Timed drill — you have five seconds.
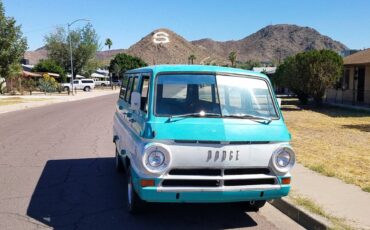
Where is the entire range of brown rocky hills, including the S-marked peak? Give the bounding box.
[25,24,347,64]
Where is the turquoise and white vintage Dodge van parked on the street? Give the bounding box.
[113,65,295,213]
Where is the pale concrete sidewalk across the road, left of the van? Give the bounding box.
[0,89,119,114]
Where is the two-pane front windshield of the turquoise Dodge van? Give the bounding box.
[155,74,278,118]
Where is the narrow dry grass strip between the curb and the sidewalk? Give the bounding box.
[289,192,353,230]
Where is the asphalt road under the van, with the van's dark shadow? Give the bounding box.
[0,95,299,229]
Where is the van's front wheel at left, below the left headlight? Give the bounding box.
[127,166,145,214]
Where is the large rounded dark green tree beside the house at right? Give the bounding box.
[276,50,343,104]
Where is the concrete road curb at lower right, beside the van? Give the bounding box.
[270,198,333,230]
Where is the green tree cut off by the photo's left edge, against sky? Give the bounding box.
[0,0,27,90]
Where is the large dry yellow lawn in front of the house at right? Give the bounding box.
[282,99,370,192]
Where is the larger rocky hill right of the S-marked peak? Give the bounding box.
[192,24,347,61]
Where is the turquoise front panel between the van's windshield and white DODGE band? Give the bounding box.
[150,118,291,142]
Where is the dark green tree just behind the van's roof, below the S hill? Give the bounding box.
[109,53,147,76]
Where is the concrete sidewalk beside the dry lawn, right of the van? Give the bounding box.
[292,164,370,229]
